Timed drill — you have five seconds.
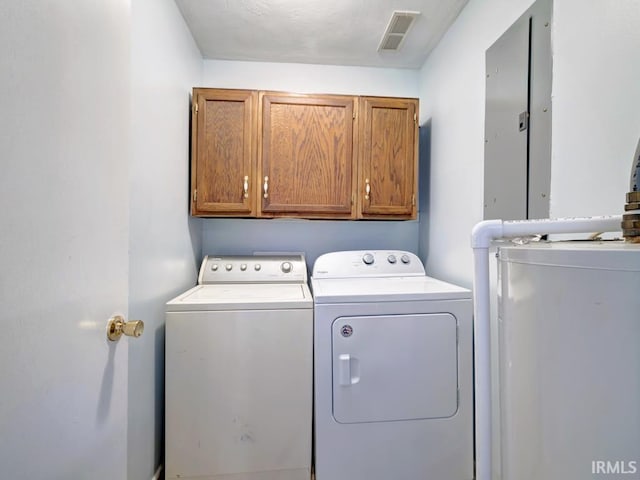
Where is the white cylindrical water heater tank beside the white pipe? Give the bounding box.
[494,241,640,480]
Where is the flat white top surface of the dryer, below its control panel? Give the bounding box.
[311,276,471,303]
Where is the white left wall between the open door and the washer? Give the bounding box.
[128,0,202,479]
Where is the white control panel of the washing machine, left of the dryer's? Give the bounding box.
[198,255,307,285]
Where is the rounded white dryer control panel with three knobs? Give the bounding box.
[312,250,425,278]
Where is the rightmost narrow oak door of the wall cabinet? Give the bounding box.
[358,97,418,219]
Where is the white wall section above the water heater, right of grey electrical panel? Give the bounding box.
[550,0,640,217]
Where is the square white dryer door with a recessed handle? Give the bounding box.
[332,313,458,423]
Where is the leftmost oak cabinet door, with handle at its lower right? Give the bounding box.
[191,88,257,216]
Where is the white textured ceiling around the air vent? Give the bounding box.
[176,0,468,68]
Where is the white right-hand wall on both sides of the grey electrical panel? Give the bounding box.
[420,0,640,286]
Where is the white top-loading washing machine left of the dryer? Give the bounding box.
[165,255,313,480]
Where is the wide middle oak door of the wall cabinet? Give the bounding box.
[258,92,356,218]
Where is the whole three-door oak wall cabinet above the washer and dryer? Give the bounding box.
[191,88,418,219]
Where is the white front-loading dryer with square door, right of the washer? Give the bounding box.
[311,251,473,480]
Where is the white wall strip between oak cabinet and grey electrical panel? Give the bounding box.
[420,0,533,287]
